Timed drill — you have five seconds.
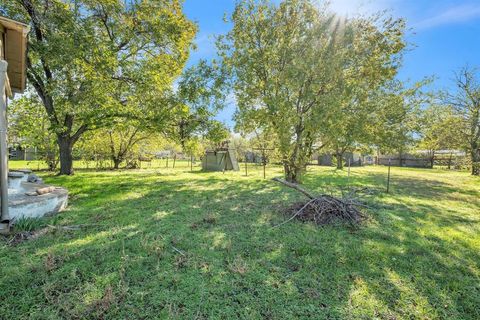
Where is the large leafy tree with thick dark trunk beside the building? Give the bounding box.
[0,0,196,174]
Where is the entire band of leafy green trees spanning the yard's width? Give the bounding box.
[0,0,480,182]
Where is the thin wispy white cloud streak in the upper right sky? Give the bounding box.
[414,4,480,29]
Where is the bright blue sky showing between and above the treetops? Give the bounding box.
[185,0,480,126]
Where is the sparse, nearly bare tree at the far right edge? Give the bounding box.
[445,67,480,176]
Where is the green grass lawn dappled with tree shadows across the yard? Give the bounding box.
[0,167,480,319]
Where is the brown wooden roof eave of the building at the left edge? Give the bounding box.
[0,16,30,92]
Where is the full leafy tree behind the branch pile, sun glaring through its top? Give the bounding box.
[219,0,405,182]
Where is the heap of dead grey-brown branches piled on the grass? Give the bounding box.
[273,178,366,227]
